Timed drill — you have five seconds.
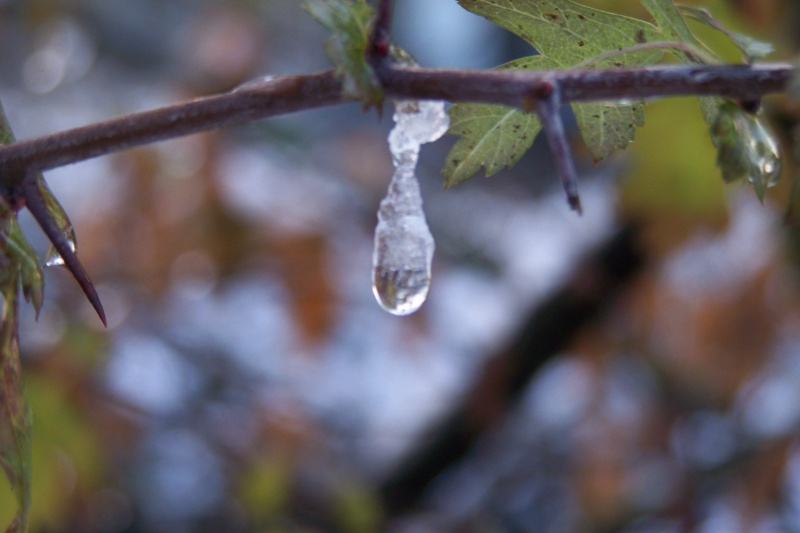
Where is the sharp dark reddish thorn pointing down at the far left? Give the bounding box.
[22,180,108,327]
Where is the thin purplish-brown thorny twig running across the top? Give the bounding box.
[0,64,794,175]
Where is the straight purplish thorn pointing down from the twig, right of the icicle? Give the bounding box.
[532,84,583,215]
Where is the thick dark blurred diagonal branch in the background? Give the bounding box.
[379,222,645,520]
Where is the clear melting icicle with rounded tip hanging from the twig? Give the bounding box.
[372,101,450,315]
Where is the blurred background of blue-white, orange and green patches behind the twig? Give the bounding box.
[0,0,800,533]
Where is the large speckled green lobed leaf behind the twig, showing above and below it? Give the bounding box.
[442,0,663,186]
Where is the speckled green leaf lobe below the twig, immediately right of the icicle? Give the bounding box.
[442,104,542,187]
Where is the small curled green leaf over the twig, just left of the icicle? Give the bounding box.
[303,0,383,107]
